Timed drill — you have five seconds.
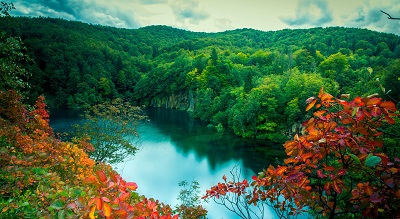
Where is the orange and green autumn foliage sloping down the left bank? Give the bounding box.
[0,90,178,218]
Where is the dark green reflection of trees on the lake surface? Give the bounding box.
[147,108,284,173]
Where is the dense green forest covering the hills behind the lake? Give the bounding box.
[0,17,400,141]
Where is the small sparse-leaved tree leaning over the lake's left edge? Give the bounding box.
[75,99,145,164]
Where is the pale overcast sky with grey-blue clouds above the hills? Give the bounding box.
[5,0,400,35]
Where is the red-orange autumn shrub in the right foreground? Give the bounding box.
[205,89,400,218]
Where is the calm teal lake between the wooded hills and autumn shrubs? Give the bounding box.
[50,108,283,219]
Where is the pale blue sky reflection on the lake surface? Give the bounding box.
[115,120,260,218]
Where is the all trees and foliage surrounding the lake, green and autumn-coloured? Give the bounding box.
[0,6,400,219]
